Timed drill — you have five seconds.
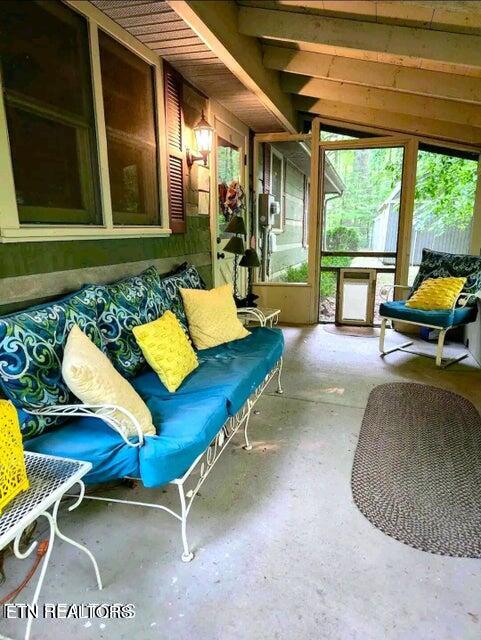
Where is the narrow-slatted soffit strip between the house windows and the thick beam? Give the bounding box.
[92,0,284,132]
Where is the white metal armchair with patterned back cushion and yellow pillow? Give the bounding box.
[379,249,481,368]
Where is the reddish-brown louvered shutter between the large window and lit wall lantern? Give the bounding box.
[164,62,186,233]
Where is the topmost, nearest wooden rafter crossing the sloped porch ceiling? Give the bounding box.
[237,3,481,73]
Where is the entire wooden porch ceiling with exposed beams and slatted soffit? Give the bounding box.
[93,0,481,148]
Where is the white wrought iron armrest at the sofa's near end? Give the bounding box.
[23,404,144,447]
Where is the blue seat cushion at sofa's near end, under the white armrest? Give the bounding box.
[24,418,140,484]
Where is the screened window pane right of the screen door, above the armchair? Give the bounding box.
[408,150,478,284]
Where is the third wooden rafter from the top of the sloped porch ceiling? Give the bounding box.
[282,74,481,127]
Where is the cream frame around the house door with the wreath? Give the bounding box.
[208,100,251,287]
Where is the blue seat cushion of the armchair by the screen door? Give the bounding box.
[379,300,477,328]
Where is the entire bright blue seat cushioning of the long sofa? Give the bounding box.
[25,328,284,487]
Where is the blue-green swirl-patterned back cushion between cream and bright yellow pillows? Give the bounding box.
[98,267,169,378]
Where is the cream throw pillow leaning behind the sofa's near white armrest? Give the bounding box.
[62,325,156,438]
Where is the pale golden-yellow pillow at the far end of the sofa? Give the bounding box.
[180,284,250,349]
